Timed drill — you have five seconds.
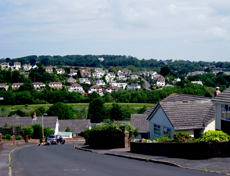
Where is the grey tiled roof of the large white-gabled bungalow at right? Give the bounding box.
[148,94,215,129]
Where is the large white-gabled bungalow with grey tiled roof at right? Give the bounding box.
[145,94,215,140]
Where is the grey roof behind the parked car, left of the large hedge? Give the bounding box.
[58,119,91,133]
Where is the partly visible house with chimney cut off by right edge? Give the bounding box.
[212,87,230,135]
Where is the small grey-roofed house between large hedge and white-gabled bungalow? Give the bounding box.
[130,114,149,139]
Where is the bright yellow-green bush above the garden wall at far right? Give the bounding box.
[198,130,230,142]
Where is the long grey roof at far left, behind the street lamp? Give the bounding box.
[0,115,57,130]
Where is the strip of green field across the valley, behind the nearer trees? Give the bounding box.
[0,103,154,117]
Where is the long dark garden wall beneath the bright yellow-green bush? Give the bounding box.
[130,142,230,159]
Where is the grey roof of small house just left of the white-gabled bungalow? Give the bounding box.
[130,114,148,133]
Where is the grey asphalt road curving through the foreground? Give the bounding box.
[12,144,220,176]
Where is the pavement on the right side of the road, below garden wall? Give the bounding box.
[74,143,230,175]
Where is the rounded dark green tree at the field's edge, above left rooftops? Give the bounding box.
[47,102,75,120]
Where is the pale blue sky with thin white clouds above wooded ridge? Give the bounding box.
[0,0,230,62]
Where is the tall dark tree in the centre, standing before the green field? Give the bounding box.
[88,97,106,123]
